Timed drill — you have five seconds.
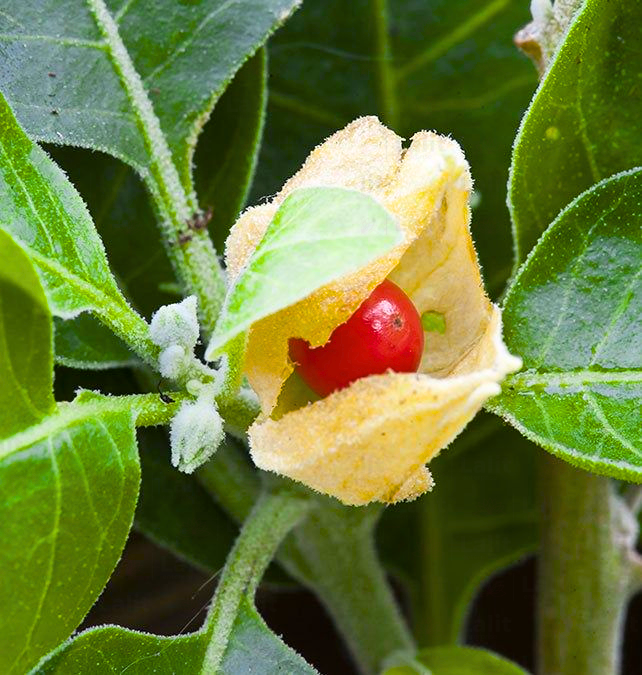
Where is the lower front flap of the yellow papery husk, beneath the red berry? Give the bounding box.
[249,307,521,505]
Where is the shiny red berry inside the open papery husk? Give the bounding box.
[290,280,424,396]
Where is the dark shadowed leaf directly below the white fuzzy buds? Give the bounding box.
[135,429,238,573]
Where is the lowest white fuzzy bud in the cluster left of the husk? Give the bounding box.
[169,398,225,473]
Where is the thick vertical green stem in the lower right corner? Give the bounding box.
[538,453,637,675]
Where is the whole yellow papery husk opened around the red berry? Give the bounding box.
[226,117,520,504]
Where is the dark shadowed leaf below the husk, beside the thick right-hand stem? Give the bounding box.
[377,414,538,645]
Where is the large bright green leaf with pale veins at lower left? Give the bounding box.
[0,396,140,673]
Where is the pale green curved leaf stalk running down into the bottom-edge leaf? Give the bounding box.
[201,491,310,675]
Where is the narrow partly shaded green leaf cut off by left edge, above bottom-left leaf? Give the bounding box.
[0,230,55,438]
